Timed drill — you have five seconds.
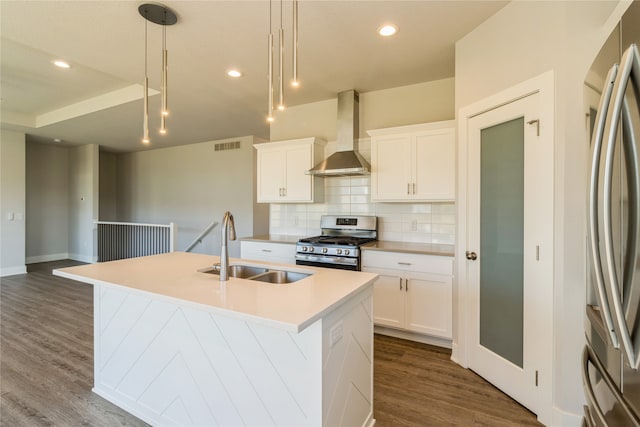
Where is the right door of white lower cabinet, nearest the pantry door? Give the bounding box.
[405,274,452,339]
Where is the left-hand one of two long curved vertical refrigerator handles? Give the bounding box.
[589,64,620,348]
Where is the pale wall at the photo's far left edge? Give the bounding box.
[0,130,27,277]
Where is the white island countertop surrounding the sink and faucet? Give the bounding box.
[53,252,377,332]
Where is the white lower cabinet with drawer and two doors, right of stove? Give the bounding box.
[362,250,453,339]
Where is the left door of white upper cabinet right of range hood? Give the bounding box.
[371,135,412,200]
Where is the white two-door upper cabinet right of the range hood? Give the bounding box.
[367,120,456,202]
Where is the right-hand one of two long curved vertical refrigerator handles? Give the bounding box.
[603,45,640,369]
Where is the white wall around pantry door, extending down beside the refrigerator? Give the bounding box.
[455,1,628,426]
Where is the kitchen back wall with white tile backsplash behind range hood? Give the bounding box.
[270,78,455,237]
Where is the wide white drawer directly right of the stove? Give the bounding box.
[362,250,453,276]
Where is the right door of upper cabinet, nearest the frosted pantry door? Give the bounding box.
[412,129,456,200]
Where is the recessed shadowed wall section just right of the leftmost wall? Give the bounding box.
[26,142,69,264]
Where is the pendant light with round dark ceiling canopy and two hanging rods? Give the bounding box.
[138,3,178,144]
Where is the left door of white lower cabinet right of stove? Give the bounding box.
[373,271,404,328]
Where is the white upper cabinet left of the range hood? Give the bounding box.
[254,138,326,203]
